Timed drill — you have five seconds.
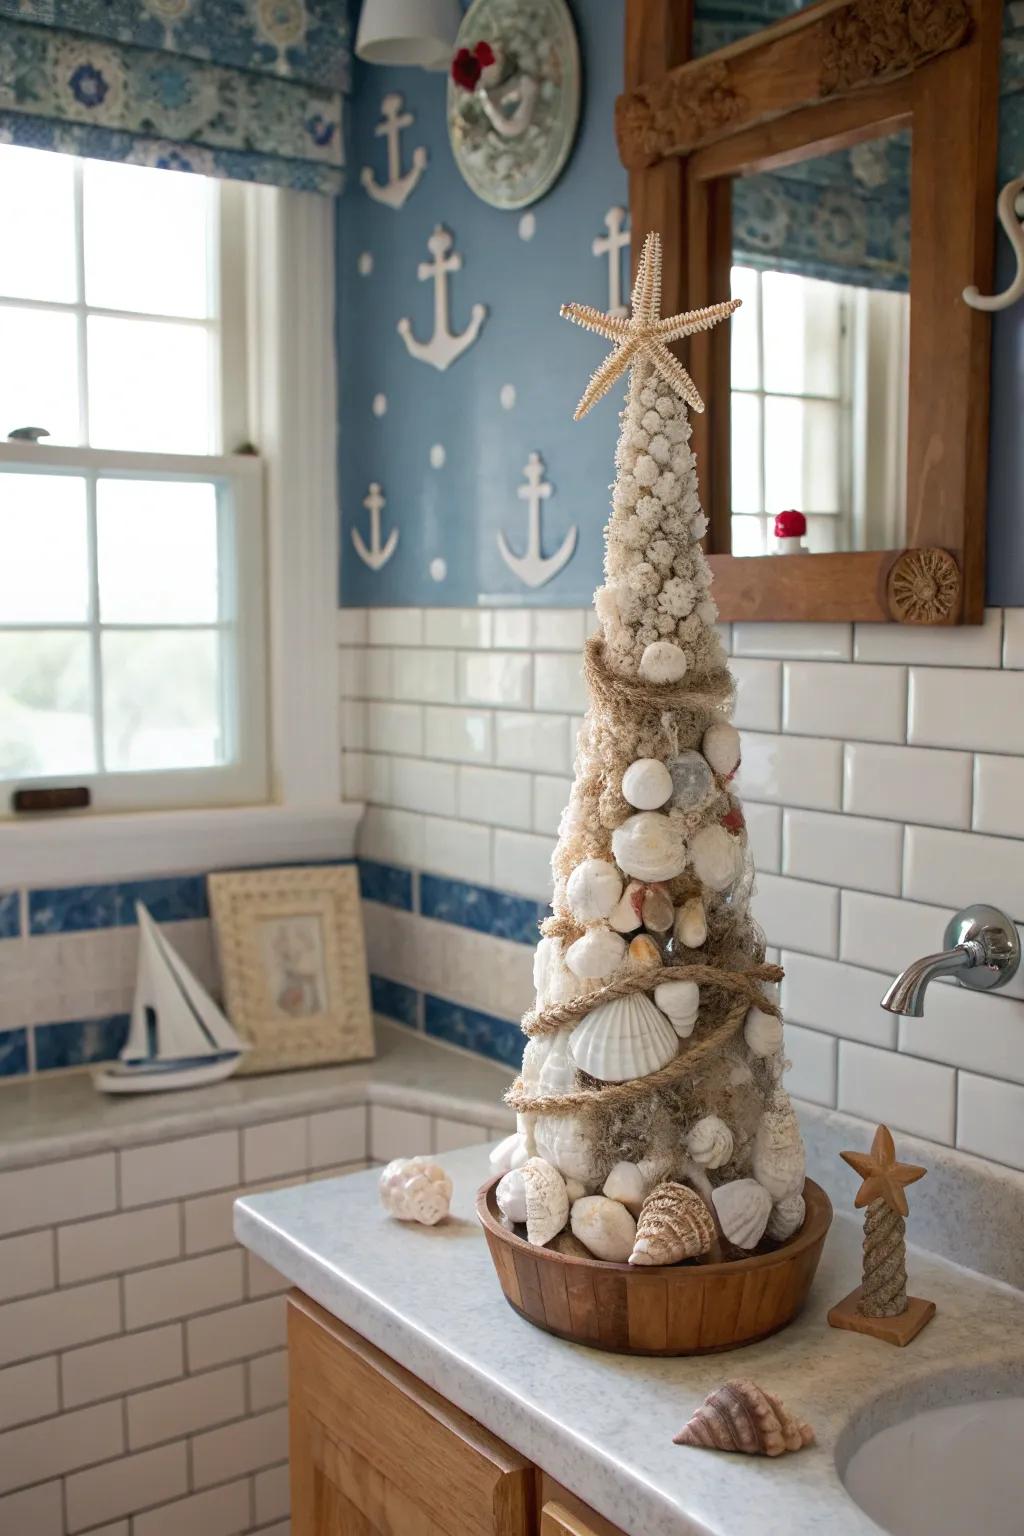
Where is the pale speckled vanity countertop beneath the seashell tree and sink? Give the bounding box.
[235,1147,1024,1536]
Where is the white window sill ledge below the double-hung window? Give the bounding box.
[0,800,364,889]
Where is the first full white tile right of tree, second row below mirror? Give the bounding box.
[783,662,907,742]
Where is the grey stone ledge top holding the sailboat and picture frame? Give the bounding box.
[0,1017,514,1172]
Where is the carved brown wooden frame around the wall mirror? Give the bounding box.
[626,0,1003,624]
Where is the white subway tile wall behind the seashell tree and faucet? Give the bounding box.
[338,608,1024,1169]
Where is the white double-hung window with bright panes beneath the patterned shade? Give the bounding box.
[0,146,266,814]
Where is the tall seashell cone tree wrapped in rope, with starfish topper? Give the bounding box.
[493,235,804,1264]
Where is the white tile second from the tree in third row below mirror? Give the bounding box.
[843,742,972,826]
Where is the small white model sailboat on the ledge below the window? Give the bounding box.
[94,902,249,1094]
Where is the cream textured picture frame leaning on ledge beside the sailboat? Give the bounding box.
[207,865,373,1072]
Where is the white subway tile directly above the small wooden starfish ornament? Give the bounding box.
[837,1040,956,1146]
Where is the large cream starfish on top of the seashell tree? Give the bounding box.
[560,233,742,421]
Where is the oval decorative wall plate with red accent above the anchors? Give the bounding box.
[448,0,580,209]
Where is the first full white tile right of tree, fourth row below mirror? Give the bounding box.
[781,809,903,895]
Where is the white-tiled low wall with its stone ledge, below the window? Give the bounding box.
[0,1023,508,1536]
